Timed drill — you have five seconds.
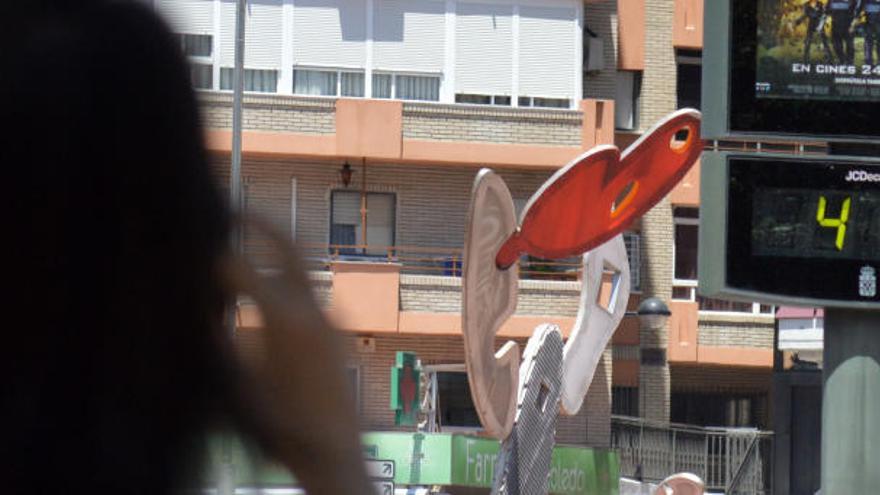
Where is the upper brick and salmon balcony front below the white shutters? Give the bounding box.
[199,91,614,169]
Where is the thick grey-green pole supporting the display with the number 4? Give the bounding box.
[822,309,880,495]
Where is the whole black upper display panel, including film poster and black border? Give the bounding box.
[729,0,880,140]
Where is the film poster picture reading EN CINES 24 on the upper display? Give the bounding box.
[755,0,880,102]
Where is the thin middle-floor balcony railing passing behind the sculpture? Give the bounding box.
[288,243,582,281]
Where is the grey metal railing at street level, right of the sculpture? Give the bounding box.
[611,416,773,495]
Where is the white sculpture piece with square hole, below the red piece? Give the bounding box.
[561,234,630,416]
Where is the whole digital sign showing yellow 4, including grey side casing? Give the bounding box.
[699,152,880,307]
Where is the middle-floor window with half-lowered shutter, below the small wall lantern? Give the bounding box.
[330,191,396,256]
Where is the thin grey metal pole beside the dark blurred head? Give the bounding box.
[217,0,247,495]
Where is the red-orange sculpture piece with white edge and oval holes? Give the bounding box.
[495,109,703,269]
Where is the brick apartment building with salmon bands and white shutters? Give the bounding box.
[152,0,773,464]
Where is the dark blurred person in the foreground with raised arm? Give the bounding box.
[0,1,369,495]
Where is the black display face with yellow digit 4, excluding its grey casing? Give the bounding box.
[726,157,880,302]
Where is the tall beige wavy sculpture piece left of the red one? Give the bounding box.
[461,169,520,439]
